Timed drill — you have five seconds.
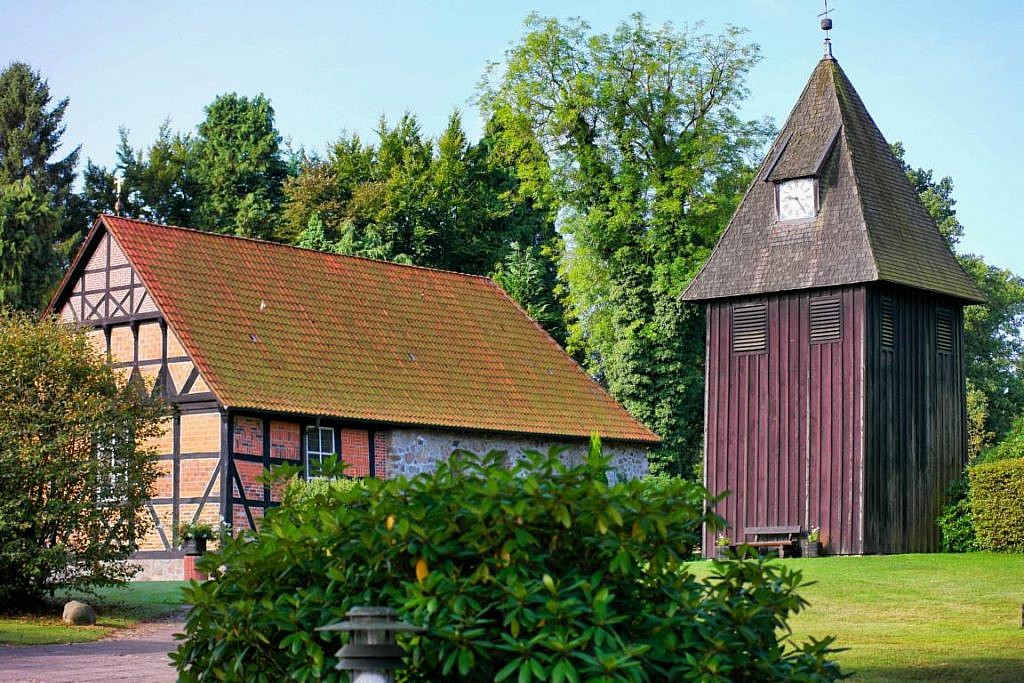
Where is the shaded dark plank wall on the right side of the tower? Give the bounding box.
[864,288,967,553]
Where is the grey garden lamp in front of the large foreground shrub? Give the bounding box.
[316,607,423,683]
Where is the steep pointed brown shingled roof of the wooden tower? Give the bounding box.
[683,56,984,303]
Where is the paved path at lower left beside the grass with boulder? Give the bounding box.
[0,612,184,683]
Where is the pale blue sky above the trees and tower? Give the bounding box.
[0,0,1024,273]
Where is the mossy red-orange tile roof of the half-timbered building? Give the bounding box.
[92,216,657,443]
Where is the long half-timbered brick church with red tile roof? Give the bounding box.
[49,215,659,579]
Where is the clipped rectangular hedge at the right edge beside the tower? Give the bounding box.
[968,458,1024,553]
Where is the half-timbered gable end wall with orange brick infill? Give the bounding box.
[59,227,222,559]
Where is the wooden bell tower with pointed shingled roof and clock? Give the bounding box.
[683,45,983,554]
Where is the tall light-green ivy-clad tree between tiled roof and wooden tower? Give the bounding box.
[480,14,771,474]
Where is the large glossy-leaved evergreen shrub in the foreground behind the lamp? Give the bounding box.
[172,449,840,683]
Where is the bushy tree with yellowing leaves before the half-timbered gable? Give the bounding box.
[0,313,163,605]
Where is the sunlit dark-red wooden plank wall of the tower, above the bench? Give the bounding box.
[705,287,865,554]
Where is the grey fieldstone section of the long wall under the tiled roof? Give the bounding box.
[386,429,647,479]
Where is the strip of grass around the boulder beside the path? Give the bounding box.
[0,581,185,645]
